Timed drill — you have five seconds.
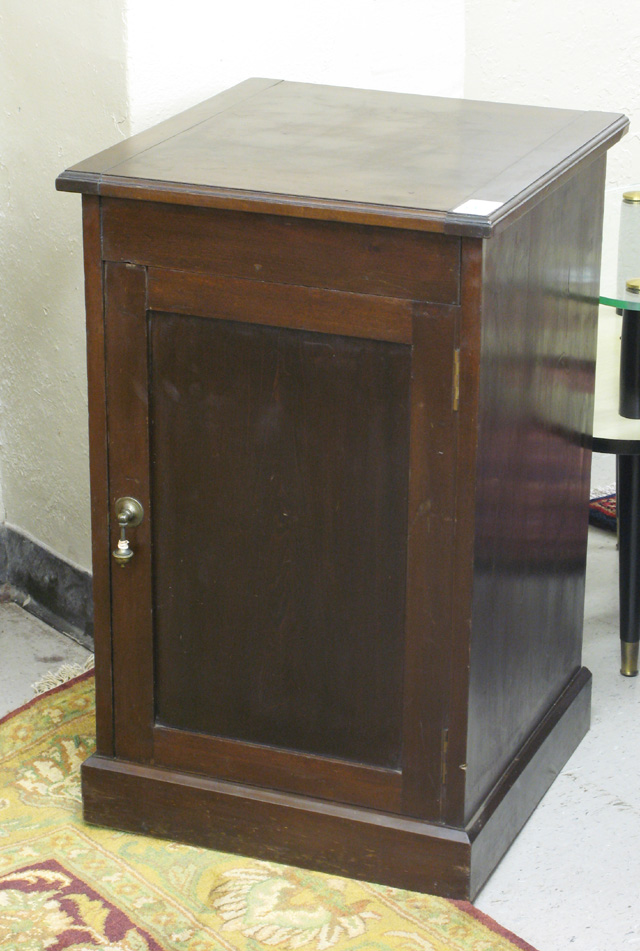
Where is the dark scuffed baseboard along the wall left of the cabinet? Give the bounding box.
[0,524,93,649]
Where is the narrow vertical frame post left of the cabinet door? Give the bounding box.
[82,195,113,756]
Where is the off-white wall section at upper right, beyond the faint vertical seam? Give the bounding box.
[464,0,640,186]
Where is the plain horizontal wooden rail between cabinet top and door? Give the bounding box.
[103,200,460,304]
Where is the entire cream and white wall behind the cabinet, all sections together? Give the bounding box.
[0,0,640,580]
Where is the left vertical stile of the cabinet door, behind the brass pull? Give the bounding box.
[105,264,154,762]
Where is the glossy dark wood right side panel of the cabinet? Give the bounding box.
[465,158,605,818]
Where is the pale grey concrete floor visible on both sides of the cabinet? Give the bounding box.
[0,457,640,951]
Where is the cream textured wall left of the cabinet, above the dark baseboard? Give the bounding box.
[0,0,128,567]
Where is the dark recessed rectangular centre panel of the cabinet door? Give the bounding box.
[149,312,410,768]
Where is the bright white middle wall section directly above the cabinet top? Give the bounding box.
[127,0,464,131]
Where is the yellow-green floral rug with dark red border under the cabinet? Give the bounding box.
[0,674,533,951]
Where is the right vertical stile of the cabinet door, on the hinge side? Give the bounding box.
[403,307,459,821]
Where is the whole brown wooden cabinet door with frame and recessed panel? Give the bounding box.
[106,264,453,813]
